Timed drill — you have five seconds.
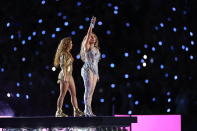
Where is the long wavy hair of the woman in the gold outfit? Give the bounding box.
[53,37,72,67]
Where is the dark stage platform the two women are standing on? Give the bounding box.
[0,116,137,129]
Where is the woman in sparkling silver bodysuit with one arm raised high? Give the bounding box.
[80,17,100,116]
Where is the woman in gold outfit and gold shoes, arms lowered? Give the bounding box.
[54,37,84,117]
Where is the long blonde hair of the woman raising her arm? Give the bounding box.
[80,33,100,62]
